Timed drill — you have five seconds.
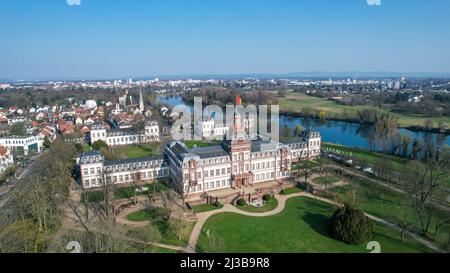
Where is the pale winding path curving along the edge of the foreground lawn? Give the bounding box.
[186,192,442,253]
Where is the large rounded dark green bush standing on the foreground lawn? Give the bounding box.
[330,204,372,245]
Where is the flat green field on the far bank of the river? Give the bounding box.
[279,93,450,127]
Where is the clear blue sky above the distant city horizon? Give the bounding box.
[0,0,450,80]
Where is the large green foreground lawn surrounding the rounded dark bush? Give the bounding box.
[198,197,430,253]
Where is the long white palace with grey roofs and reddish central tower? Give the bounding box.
[79,125,321,195]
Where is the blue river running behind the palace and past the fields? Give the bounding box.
[158,96,450,150]
